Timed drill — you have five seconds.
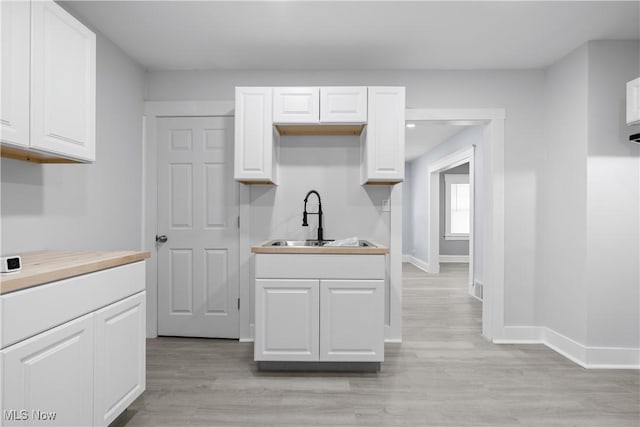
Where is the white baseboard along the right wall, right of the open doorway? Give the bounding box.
[493,326,640,369]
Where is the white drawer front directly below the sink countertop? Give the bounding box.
[255,254,386,279]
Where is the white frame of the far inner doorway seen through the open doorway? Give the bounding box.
[427,147,476,295]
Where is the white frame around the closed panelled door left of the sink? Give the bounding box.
[140,101,249,338]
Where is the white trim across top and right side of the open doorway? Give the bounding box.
[406,108,506,341]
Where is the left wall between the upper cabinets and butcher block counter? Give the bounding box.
[0,34,144,254]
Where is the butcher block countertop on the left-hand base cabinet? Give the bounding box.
[0,251,151,295]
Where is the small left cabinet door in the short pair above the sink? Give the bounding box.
[273,87,320,123]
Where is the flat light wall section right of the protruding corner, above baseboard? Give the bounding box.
[586,41,640,349]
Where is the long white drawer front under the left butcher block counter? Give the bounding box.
[0,262,145,348]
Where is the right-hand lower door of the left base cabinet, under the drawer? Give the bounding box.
[93,291,146,426]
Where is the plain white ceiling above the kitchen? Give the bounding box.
[62,0,640,70]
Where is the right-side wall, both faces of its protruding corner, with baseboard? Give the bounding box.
[535,41,640,366]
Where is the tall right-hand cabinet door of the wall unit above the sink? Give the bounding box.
[361,87,405,184]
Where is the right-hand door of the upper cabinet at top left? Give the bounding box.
[31,1,96,161]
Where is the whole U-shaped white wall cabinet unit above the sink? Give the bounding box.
[235,86,405,184]
